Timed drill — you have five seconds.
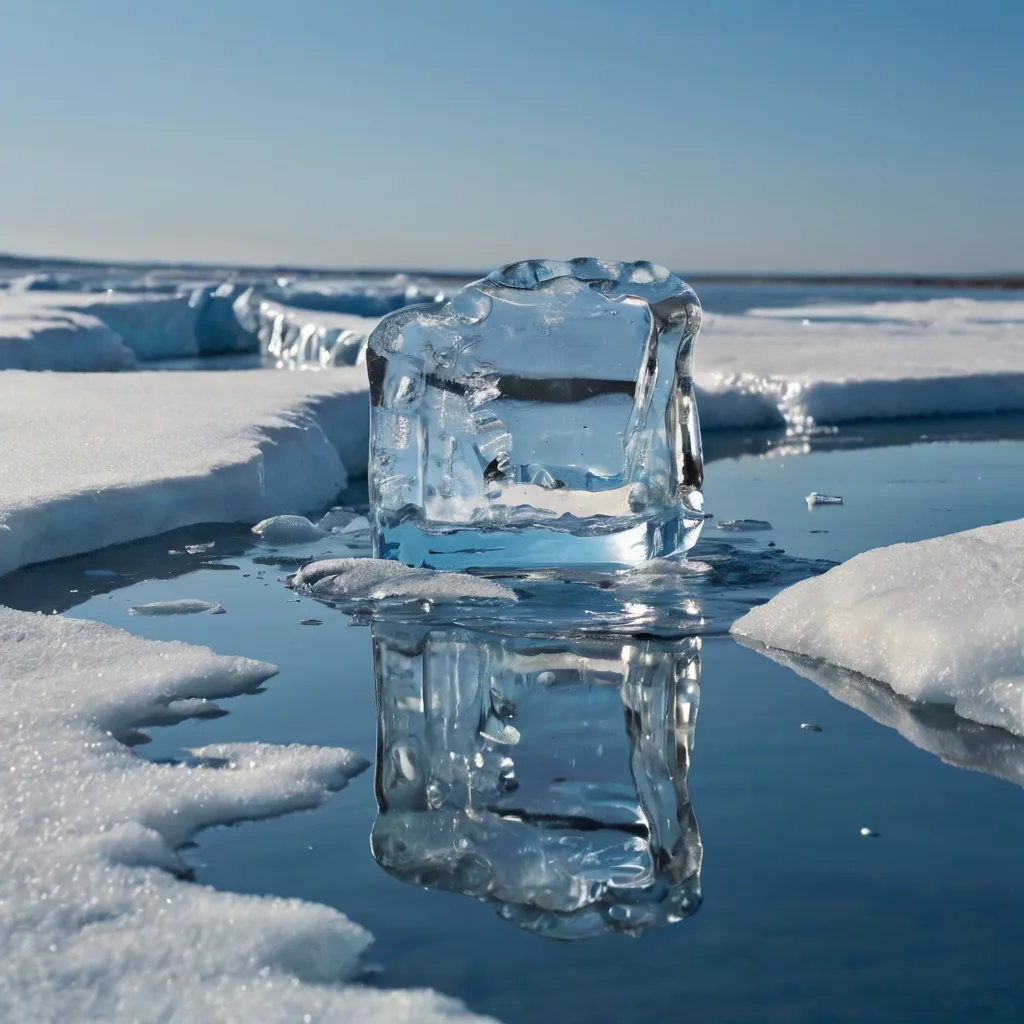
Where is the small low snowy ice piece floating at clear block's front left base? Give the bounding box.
[289,558,516,602]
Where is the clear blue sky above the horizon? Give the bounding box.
[0,0,1024,272]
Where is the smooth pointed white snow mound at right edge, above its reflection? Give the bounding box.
[732,519,1024,735]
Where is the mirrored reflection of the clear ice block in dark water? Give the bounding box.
[371,623,701,939]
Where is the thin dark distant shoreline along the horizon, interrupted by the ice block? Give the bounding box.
[0,253,1024,292]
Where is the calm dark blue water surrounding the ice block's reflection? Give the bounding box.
[0,419,1024,1024]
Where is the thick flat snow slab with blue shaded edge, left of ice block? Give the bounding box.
[0,369,369,574]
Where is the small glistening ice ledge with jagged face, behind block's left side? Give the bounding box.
[233,289,380,370]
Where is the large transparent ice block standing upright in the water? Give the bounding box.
[367,259,703,568]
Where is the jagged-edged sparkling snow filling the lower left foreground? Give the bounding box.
[0,608,491,1024]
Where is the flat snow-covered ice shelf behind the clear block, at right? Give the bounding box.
[694,298,1024,431]
